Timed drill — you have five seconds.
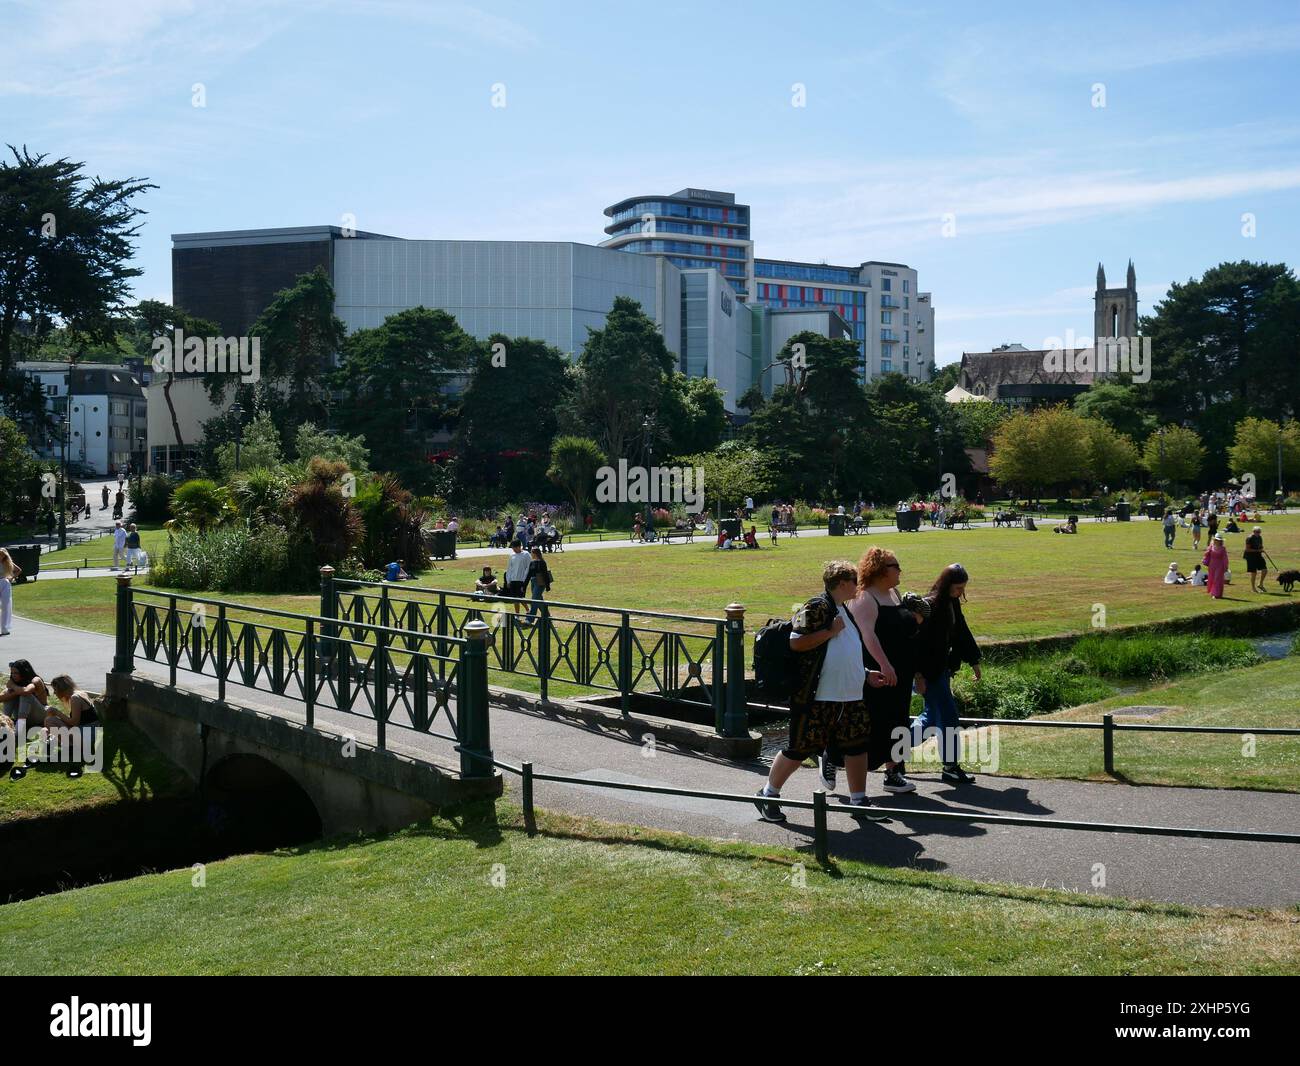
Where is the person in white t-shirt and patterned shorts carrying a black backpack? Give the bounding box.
[754,559,887,822]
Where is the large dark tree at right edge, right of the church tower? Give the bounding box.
[1143,261,1300,475]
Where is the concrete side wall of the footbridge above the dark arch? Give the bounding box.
[105,673,502,836]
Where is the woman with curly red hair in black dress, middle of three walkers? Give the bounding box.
[848,547,920,792]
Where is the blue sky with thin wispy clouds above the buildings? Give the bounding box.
[0,0,1300,363]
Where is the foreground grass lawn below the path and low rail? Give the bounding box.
[0,803,1300,975]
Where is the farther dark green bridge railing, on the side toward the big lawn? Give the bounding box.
[327,567,749,737]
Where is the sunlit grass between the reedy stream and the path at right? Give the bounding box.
[935,655,1300,792]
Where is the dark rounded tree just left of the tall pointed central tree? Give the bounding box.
[456,334,573,499]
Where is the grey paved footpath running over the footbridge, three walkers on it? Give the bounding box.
[0,616,1300,906]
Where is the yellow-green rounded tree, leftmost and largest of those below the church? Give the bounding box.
[988,404,1091,497]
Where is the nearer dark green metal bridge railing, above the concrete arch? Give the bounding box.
[113,577,493,777]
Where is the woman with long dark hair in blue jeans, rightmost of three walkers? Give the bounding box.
[911,563,980,785]
